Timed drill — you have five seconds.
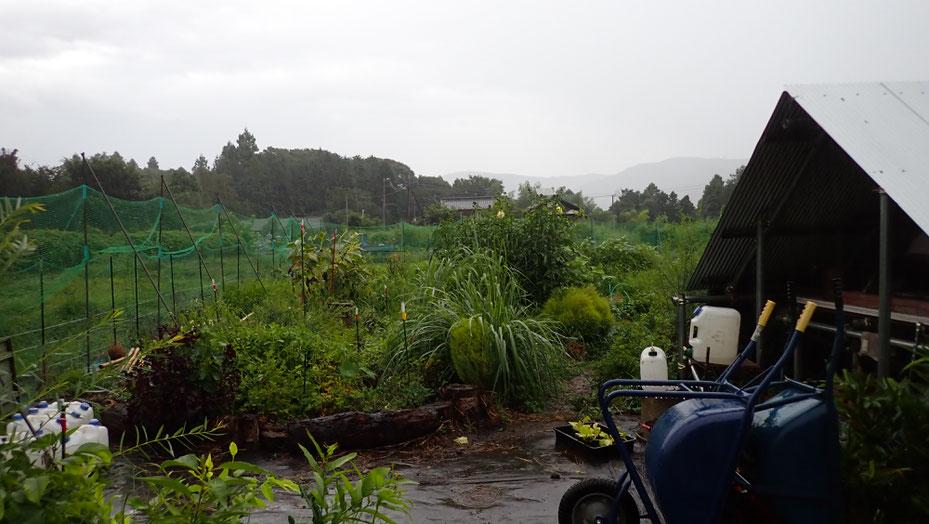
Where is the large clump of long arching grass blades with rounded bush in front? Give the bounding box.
[387,251,565,402]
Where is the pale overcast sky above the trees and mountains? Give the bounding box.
[0,0,929,176]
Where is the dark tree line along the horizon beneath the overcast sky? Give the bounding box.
[0,129,738,225]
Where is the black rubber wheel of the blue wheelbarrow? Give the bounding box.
[558,479,639,524]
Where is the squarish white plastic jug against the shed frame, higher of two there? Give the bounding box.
[689,306,741,365]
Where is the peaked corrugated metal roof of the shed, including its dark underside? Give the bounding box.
[687,82,929,290]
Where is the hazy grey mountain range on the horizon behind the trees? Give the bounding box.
[442,157,748,209]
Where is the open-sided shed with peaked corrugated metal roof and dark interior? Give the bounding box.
[688,82,929,375]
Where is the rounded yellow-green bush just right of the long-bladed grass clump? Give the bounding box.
[542,286,616,349]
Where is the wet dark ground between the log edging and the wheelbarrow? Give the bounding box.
[241,418,643,523]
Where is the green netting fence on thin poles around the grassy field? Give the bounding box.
[0,186,660,390]
